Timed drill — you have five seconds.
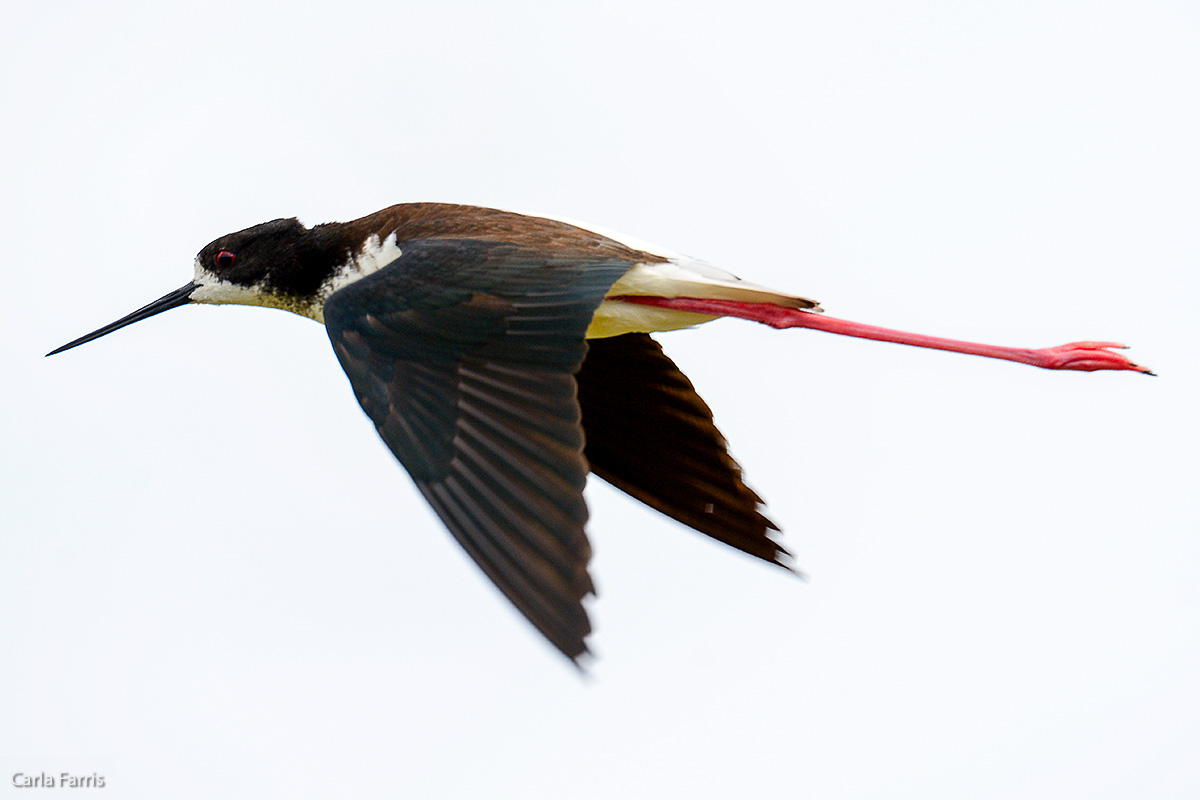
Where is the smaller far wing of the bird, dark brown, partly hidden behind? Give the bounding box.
[576,333,787,566]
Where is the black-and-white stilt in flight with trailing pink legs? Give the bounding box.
[47,203,1153,666]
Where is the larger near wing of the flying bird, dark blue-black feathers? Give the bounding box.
[324,239,631,658]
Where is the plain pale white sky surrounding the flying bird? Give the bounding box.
[0,0,1200,800]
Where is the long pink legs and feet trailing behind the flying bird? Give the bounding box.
[608,295,1154,375]
